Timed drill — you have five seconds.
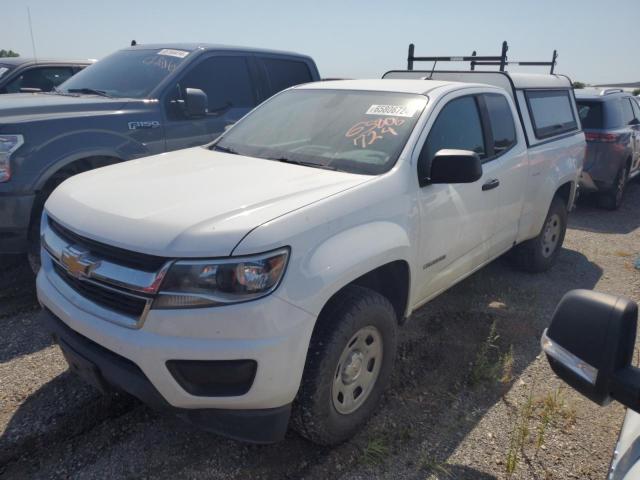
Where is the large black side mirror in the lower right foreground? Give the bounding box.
[542,290,640,411]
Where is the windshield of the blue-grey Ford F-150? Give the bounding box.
[58,48,189,98]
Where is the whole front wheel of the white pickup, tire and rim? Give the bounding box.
[291,285,398,445]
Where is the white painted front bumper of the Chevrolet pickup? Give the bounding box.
[37,255,315,441]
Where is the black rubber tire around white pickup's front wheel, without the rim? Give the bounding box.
[291,285,398,445]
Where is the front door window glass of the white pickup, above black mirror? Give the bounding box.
[418,96,486,178]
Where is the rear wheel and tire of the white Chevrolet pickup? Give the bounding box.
[511,196,567,272]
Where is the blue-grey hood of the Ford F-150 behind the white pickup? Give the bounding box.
[0,93,127,124]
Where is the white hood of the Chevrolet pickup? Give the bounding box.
[45,147,373,258]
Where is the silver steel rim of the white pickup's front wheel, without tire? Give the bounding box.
[331,326,383,415]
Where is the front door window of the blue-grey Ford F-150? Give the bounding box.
[179,56,256,113]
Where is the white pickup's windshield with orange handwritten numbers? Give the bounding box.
[211,89,427,175]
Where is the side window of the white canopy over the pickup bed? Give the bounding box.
[525,90,578,138]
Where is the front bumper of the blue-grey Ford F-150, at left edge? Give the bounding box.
[0,194,35,254]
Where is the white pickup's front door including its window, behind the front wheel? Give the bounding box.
[417,93,499,303]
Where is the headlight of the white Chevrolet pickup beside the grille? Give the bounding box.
[152,248,289,308]
